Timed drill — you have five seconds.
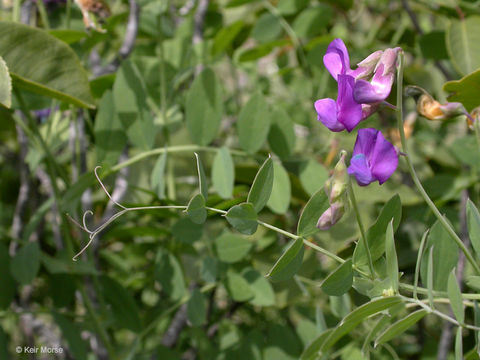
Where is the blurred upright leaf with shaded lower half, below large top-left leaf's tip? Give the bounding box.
[95,90,127,165]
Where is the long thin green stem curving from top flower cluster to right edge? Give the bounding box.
[397,52,480,274]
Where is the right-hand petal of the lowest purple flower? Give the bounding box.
[370,131,398,185]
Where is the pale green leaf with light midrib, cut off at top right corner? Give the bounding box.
[446,16,480,75]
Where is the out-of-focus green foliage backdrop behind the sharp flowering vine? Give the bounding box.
[0,0,480,360]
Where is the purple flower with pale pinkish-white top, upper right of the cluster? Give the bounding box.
[353,47,400,104]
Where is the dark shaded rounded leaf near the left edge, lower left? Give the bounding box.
[10,242,40,285]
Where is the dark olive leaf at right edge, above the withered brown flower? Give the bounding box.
[443,69,480,111]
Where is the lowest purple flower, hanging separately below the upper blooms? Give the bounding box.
[348,128,398,186]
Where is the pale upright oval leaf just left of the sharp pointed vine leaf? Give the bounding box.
[212,147,235,199]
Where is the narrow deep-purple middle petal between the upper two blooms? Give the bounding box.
[337,75,362,131]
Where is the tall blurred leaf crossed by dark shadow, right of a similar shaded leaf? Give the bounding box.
[113,60,157,150]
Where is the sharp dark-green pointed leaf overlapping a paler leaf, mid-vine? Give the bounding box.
[247,157,274,213]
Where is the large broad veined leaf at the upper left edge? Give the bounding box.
[0,21,94,108]
